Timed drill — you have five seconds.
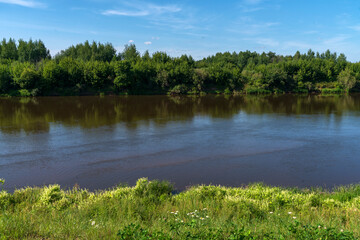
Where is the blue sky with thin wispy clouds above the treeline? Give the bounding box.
[0,0,360,62]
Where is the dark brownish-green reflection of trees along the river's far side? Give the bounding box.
[0,95,360,133]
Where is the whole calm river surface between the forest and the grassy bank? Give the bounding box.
[0,95,360,190]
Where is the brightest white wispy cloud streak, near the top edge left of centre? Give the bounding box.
[102,3,181,17]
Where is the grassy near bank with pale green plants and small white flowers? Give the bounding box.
[0,179,360,239]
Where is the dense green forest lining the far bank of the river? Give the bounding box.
[0,39,360,96]
